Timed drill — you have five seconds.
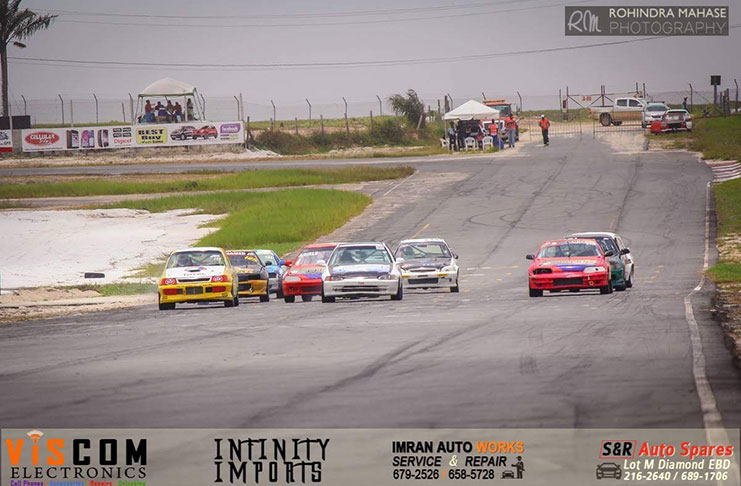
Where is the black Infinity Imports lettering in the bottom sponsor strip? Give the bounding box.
[214,438,329,484]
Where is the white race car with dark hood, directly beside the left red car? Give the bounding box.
[317,242,404,302]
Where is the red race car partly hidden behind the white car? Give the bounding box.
[283,243,337,303]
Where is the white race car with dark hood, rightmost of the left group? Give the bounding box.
[395,238,460,292]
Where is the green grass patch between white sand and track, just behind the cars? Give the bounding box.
[106,189,372,277]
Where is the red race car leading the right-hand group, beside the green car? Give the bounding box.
[527,239,613,297]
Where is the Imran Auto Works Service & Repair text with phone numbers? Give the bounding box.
[391,440,525,480]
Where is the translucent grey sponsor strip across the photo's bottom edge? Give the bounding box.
[0,429,739,486]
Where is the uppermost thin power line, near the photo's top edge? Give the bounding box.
[49,0,595,29]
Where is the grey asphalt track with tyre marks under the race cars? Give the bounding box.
[0,137,741,428]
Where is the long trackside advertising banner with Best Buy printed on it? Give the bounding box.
[22,121,244,152]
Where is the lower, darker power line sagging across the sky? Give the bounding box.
[8,31,741,71]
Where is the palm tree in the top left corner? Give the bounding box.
[0,0,57,116]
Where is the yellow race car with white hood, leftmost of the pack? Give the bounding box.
[159,247,239,310]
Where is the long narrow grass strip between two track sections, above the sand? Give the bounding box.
[0,167,414,199]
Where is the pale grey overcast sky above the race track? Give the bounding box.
[10,0,741,103]
